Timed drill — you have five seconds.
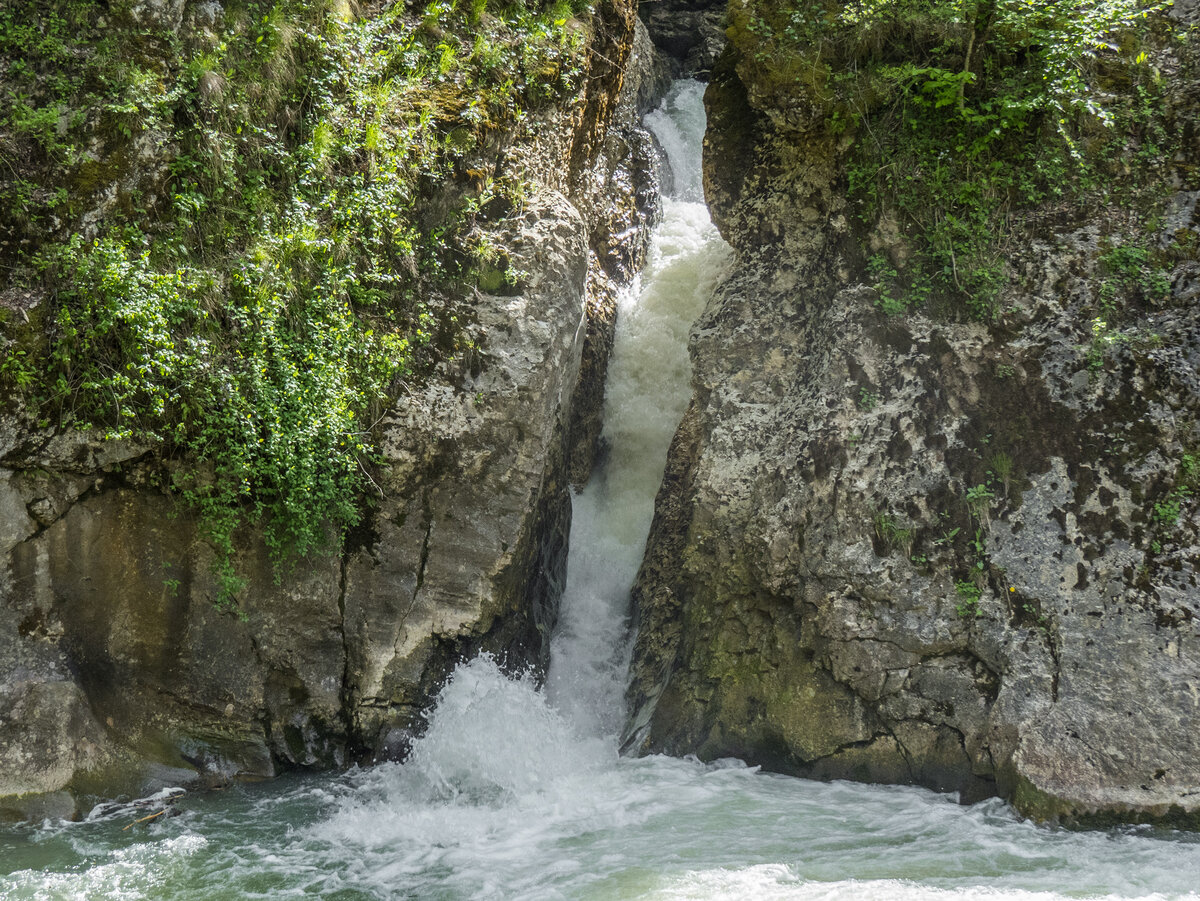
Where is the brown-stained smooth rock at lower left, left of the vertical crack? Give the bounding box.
[0,479,347,806]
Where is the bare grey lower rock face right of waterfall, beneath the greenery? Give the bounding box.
[634,248,1200,819]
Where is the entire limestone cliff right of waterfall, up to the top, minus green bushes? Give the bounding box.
[630,0,1200,825]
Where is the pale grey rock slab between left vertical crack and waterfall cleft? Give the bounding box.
[344,194,588,753]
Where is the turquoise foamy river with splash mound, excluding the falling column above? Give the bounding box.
[0,691,1200,901]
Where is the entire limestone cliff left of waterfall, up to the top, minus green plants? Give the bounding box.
[0,0,655,816]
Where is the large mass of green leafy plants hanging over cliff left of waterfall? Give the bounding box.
[0,0,587,602]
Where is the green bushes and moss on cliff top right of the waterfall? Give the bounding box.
[731,0,1171,319]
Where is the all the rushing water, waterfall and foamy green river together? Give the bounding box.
[0,82,1200,901]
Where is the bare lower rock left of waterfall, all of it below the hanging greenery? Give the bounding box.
[0,184,609,810]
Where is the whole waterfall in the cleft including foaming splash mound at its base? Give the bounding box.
[309,80,730,815]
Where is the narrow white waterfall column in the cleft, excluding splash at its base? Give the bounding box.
[547,80,730,735]
